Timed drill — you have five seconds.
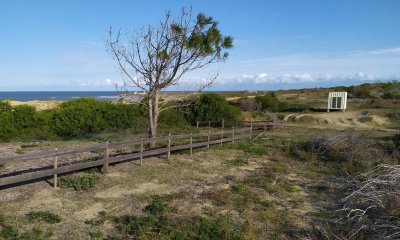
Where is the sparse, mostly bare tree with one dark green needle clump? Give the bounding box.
[107,9,233,146]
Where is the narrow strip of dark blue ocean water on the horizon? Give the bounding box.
[0,91,120,102]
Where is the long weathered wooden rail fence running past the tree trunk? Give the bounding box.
[0,124,265,189]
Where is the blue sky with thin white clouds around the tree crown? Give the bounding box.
[0,0,400,91]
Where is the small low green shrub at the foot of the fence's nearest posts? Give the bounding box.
[58,174,99,191]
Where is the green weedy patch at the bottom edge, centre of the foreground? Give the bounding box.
[109,197,245,239]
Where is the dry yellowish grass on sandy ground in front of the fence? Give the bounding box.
[0,135,318,239]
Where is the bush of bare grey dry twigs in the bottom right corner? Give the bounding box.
[307,164,400,240]
